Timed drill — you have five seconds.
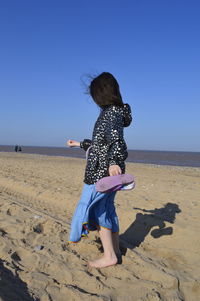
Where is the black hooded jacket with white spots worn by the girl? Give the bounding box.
[80,104,132,184]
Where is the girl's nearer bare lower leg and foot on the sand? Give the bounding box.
[89,227,117,268]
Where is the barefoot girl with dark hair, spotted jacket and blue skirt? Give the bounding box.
[67,72,132,268]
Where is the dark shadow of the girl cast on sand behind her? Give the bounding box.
[120,203,181,251]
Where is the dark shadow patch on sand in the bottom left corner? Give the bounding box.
[0,259,36,301]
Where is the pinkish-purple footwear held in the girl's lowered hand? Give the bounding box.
[95,174,134,192]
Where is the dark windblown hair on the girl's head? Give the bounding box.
[89,72,123,108]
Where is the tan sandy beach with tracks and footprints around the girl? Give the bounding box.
[0,152,200,301]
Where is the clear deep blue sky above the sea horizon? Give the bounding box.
[0,0,200,151]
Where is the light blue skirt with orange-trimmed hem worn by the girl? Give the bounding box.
[69,184,119,242]
